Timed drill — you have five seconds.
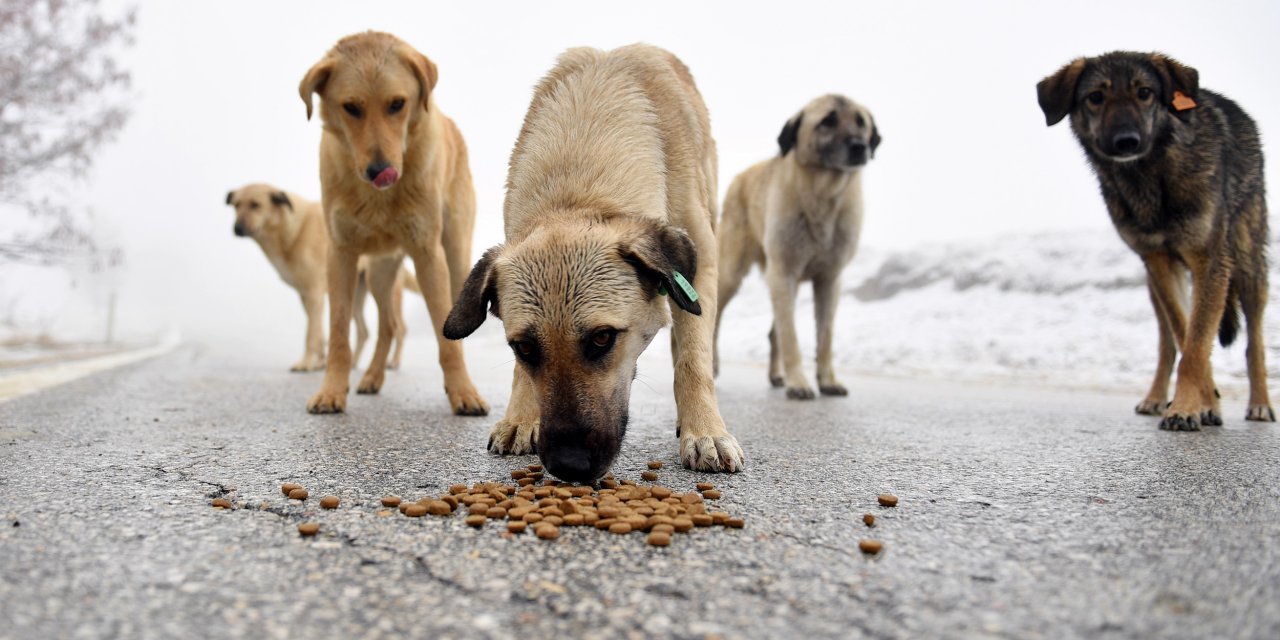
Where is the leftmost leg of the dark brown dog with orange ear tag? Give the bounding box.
[1134,252,1187,416]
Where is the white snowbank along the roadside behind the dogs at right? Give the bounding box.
[719,232,1280,401]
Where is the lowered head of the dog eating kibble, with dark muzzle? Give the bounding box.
[444,216,701,481]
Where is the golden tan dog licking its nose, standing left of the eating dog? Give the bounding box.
[298,31,489,416]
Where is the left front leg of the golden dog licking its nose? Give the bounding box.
[307,246,360,413]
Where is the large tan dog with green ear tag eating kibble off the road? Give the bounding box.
[444,45,742,481]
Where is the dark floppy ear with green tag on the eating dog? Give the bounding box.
[621,223,703,316]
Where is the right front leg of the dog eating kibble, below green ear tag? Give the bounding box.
[671,257,745,472]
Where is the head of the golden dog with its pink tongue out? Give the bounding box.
[298,31,436,189]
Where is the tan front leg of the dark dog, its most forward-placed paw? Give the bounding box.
[1160,249,1231,431]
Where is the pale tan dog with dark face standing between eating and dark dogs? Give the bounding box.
[716,95,881,399]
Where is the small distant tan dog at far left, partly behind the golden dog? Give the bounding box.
[227,184,417,371]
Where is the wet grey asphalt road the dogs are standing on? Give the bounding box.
[0,340,1280,640]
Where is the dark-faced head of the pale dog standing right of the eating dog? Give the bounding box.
[778,93,881,172]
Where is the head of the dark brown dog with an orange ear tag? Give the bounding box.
[1036,51,1199,163]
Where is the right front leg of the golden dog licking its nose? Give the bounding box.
[412,241,489,416]
